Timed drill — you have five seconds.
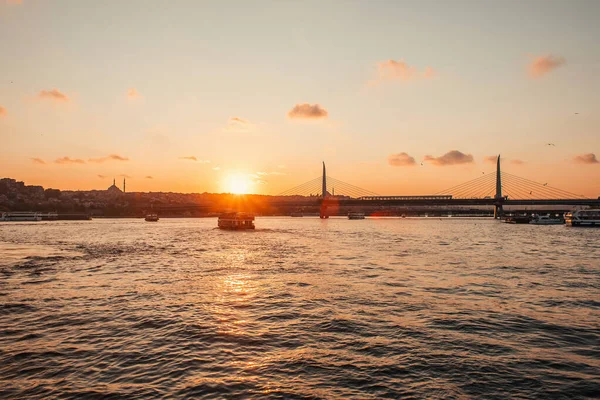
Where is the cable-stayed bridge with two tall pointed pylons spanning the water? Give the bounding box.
[276,156,600,218]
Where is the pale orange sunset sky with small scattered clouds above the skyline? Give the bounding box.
[0,0,600,197]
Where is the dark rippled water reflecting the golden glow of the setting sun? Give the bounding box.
[0,217,600,399]
